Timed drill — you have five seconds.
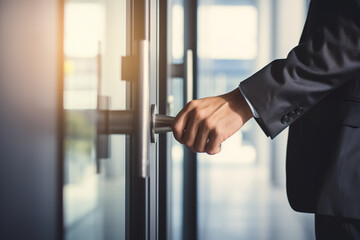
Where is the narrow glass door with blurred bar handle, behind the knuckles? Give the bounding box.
[167,0,198,240]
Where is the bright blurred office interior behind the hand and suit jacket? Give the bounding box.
[172,0,314,240]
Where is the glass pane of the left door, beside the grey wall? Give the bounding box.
[63,0,126,240]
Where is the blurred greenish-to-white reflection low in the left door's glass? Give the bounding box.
[64,111,97,226]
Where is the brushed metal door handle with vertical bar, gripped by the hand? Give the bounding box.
[97,40,175,178]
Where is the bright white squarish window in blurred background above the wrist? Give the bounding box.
[198,5,257,60]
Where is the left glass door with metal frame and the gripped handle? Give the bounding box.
[63,0,165,240]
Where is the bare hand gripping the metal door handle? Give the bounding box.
[173,89,253,154]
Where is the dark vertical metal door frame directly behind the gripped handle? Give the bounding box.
[126,0,158,240]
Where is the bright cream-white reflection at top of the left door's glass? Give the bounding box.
[64,1,105,109]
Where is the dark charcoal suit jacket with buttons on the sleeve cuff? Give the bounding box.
[240,0,360,219]
